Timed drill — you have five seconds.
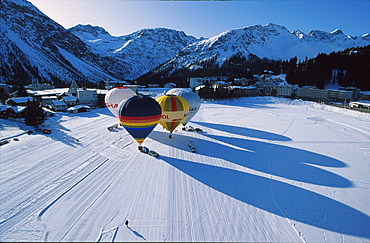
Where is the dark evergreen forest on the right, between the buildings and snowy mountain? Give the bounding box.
[137,46,370,90]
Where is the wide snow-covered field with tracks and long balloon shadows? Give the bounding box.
[0,94,370,242]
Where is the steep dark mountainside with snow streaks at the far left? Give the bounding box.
[0,0,123,83]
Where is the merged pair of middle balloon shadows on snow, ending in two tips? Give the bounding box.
[153,132,352,188]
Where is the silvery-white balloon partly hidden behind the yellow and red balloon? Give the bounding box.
[166,88,201,127]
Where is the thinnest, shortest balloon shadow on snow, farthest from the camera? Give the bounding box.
[192,121,292,141]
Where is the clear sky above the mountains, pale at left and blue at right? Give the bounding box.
[29,0,370,38]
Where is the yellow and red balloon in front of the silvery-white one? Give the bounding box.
[156,95,189,138]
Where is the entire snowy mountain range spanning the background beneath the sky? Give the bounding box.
[0,0,370,84]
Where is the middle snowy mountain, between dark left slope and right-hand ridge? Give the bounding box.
[69,25,198,79]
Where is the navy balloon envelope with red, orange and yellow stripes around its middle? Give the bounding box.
[118,95,162,144]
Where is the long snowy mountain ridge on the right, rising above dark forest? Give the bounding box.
[150,23,370,75]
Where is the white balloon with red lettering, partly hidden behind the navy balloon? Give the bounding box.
[105,87,136,117]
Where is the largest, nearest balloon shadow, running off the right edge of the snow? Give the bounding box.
[161,156,370,238]
